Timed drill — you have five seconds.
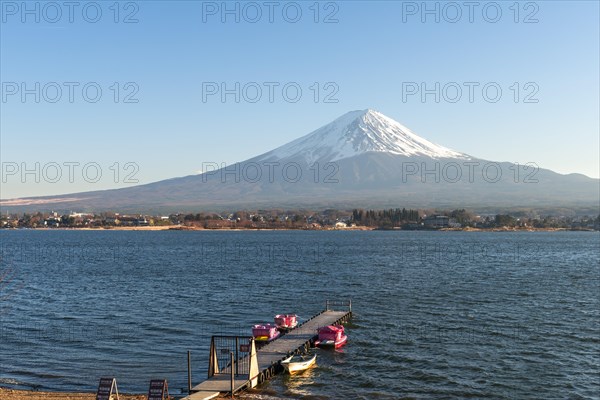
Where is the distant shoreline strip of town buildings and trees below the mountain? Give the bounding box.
[0,208,600,231]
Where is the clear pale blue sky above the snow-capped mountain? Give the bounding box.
[0,1,600,198]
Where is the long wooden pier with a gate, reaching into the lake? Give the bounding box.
[182,300,352,400]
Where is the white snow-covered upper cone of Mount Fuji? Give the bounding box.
[258,109,470,164]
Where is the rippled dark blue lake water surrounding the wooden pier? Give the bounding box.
[0,230,600,399]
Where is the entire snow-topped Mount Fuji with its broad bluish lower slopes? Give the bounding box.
[0,110,600,212]
